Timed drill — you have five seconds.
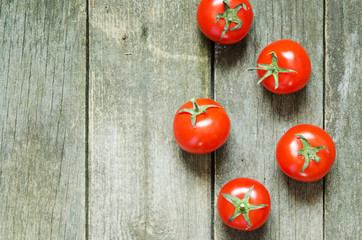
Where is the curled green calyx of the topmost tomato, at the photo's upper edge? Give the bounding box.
[215,0,249,40]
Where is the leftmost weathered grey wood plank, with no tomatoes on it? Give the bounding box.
[0,0,86,240]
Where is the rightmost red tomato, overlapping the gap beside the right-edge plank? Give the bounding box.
[276,124,336,182]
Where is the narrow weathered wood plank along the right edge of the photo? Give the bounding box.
[325,0,362,239]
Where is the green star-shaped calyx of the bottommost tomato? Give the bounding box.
[222,185,268,228]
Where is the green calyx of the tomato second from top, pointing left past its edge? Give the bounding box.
[246,52,297,89]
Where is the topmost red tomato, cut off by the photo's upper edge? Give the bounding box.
[197,0,253,44]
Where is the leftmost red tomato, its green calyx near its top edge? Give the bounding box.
[173,99,230,154]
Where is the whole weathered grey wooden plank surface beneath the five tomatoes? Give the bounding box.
[0,0,362,240]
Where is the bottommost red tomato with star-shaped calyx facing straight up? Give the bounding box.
[217,178,270,231]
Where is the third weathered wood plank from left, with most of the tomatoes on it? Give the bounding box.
[215,0,323,239]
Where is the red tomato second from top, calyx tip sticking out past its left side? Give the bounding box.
[247,39,312,94]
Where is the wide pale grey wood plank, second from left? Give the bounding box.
[89,0,212,239]
